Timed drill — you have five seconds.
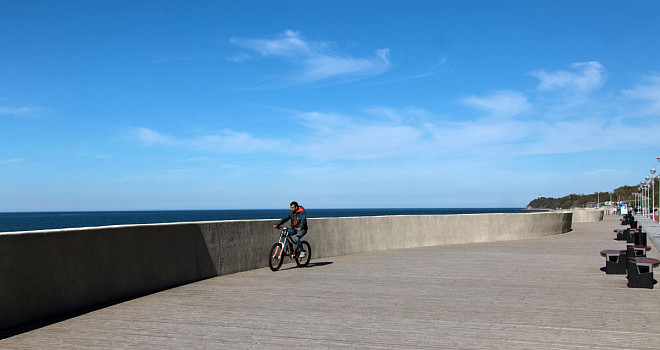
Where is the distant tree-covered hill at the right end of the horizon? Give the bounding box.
[527,186,640,209]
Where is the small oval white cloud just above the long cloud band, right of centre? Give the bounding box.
[463,91,530,117]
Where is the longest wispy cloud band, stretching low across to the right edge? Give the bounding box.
[124,100,660,164]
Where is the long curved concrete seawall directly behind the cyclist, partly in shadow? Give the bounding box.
[0,212,572,330]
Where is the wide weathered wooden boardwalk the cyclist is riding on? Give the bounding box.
[0,217,660,349]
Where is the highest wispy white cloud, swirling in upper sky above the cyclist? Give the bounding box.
[228,30,390,84]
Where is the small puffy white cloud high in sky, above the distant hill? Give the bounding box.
[532,61,606,92]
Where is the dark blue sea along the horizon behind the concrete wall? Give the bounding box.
[0,208,540,232]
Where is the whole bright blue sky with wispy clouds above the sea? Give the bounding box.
[0,0,660,211]
